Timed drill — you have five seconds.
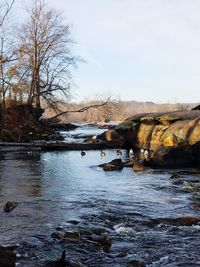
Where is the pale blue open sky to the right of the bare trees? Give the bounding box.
[16,0,200,103]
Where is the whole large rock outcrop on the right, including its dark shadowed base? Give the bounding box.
[102,110,200,168]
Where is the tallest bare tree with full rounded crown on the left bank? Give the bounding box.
[19,0,79,108]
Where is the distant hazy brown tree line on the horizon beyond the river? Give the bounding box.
[44,98,196,122]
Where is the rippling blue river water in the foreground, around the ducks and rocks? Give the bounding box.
[0,150,200,267]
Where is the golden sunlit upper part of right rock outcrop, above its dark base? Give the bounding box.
[104,110,200,151]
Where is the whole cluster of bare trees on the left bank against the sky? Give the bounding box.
[0,0,80,108]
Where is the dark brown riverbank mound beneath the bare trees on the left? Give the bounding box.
[0,105,63,142]
